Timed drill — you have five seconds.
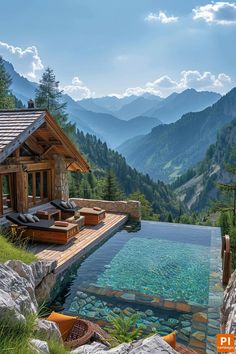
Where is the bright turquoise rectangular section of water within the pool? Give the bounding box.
[96,237,209,304]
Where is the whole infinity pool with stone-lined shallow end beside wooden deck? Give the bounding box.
[51,221,223,353]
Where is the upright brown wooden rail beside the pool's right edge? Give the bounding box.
[221,235,232,285]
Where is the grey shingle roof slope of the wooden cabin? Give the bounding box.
[0,110,45,163]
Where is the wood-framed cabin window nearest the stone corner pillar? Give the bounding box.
[28,170,51,206]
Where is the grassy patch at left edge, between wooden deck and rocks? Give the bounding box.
[0,236,37,264]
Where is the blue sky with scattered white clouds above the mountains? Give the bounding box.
[0,0,236,100]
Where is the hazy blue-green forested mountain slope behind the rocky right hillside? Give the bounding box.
[118,88,236,182]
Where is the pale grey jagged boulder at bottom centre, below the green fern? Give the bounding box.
[71,335,177,354]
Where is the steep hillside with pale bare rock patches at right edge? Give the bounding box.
[173,119,236,211]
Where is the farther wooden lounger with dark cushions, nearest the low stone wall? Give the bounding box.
[51,199,106,225]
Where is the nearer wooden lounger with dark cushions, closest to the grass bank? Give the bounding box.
[6,213,79,245]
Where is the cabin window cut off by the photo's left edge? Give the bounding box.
[0,173,14,215]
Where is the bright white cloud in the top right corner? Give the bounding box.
[193,1,236,25]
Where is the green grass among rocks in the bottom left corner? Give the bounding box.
[0,315,69,354]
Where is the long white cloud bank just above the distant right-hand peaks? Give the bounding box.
[116,70,231,97]
